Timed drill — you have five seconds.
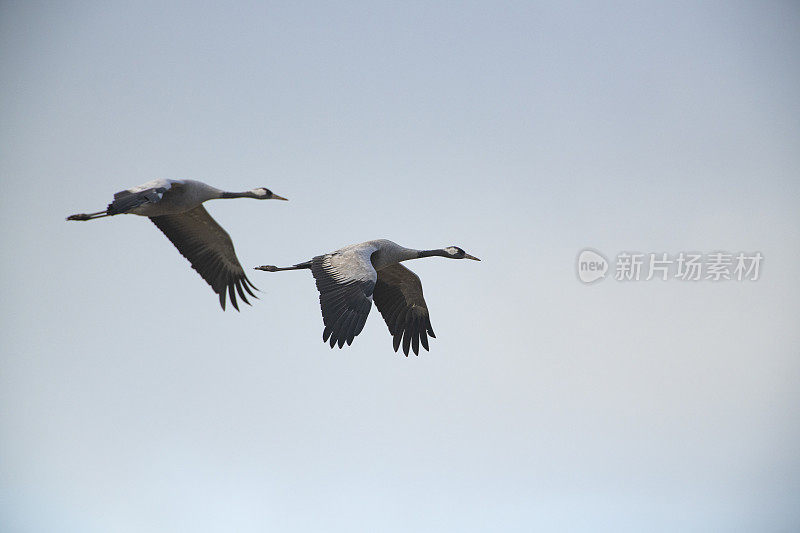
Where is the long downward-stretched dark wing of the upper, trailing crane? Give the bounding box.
[150,205,256,311]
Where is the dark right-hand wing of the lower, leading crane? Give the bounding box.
[373,263,436,357]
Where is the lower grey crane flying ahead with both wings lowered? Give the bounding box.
[256,239,480,357]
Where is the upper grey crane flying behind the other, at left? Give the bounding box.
[67,179,286,311]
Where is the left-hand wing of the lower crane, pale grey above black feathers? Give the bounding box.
[311,250,377,348]
